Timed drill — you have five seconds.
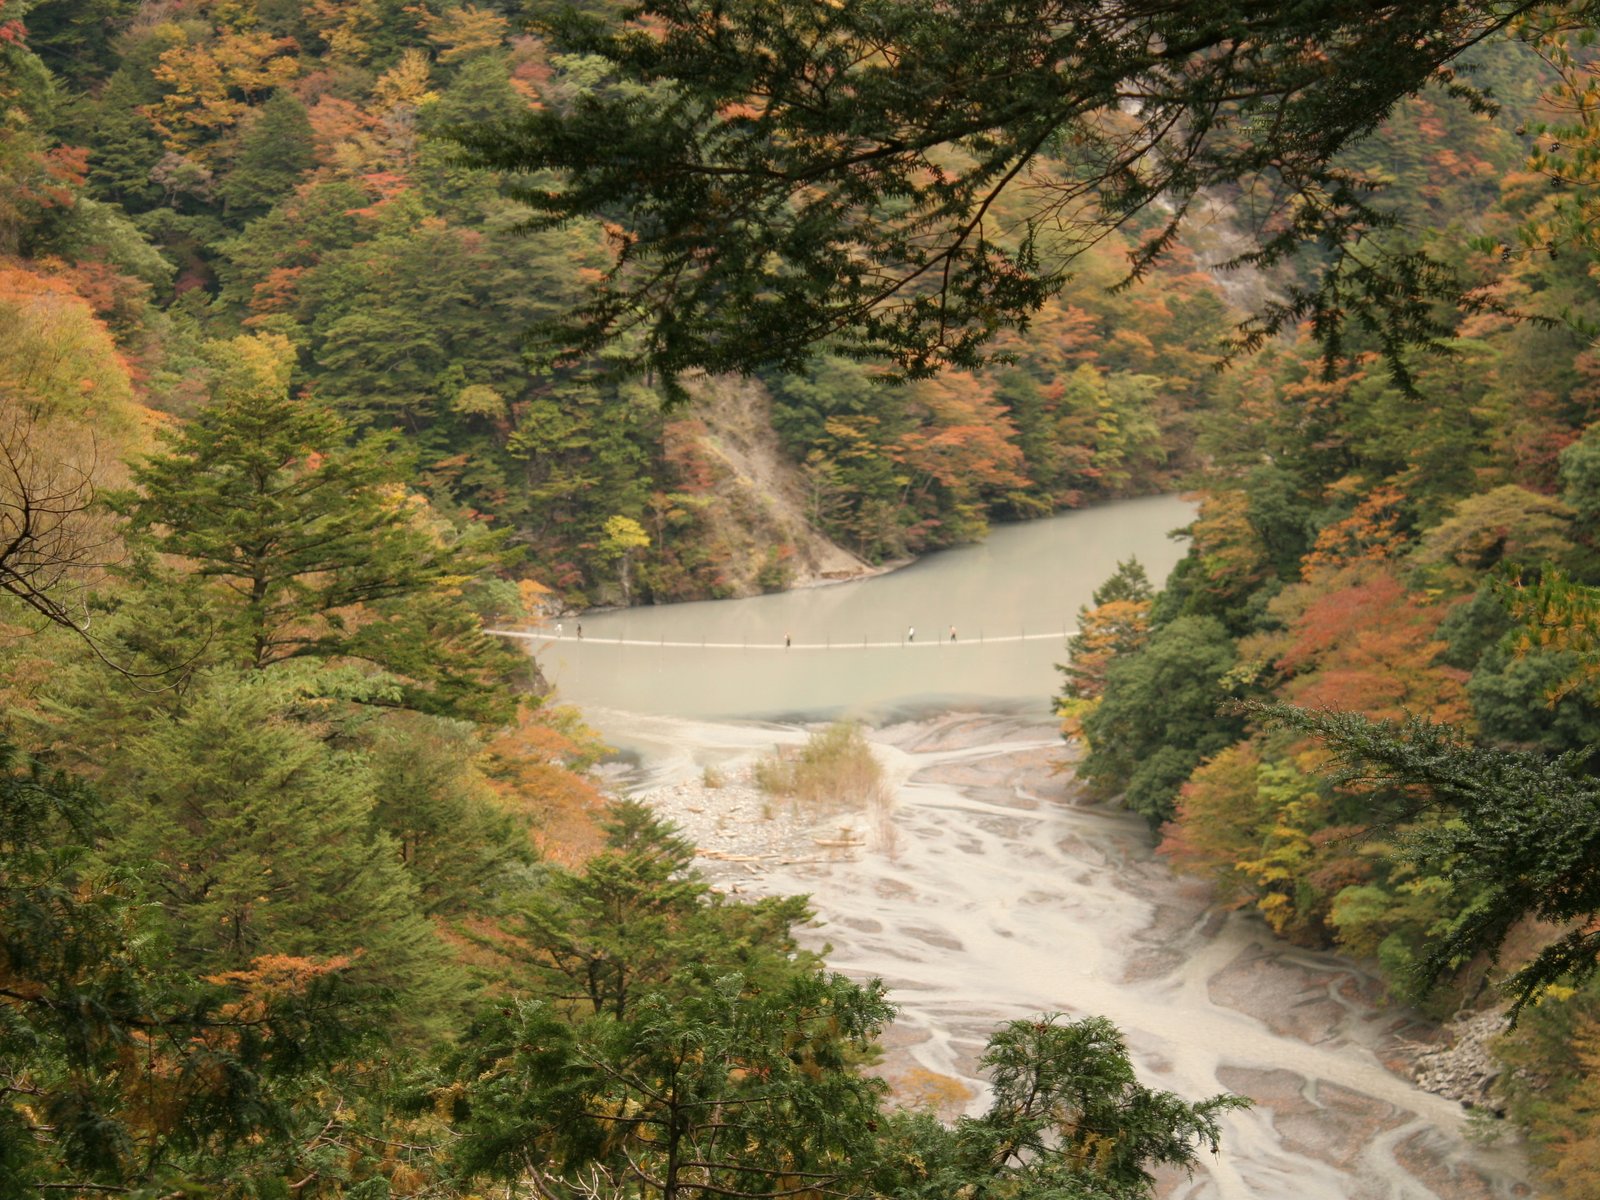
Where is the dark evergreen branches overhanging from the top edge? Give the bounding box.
[461,0,1594,390]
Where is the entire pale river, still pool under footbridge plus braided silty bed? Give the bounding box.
[508,498,1534,1200]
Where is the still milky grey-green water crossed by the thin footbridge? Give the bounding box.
[518,496,1194,723]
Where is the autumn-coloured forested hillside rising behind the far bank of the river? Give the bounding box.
[0,0,1229,605]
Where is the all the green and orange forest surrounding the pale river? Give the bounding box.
[0,0,1600,1200]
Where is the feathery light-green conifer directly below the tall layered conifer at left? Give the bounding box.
[104,672,443,1011]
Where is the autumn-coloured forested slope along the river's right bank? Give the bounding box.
[1059,42,1600,1200]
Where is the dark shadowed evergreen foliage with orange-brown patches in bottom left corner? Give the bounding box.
[0,747,389,1197]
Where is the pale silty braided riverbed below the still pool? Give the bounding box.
[620,714,1531,1200]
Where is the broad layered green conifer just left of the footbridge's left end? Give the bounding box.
[115,338,520,720]
